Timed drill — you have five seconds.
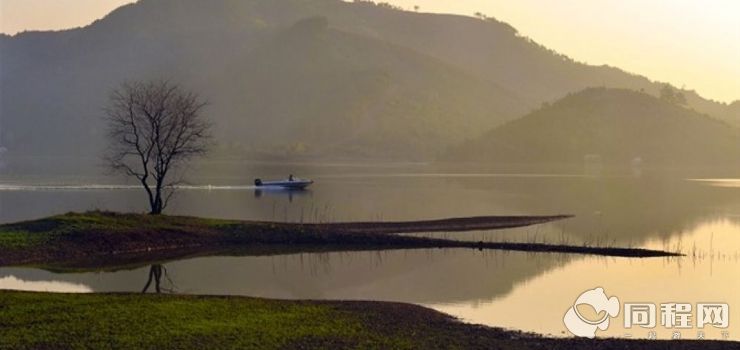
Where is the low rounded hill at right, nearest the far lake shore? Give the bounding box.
[448,88,740,165]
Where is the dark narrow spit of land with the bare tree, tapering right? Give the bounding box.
[0,212,676,267]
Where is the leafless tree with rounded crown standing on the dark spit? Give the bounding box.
[105,81,211,215]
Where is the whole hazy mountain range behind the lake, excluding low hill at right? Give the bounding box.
[0,0,740,160]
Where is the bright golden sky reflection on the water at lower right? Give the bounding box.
[427,219,740,340]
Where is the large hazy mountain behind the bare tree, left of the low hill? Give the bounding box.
[0,0,526,160]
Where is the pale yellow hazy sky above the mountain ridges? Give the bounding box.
[0,0,740,102]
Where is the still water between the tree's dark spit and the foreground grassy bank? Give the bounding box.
[0,239,740,339]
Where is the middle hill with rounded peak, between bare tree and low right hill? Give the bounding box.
[218,17,523,159]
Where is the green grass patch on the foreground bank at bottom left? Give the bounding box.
[0,292,410,349]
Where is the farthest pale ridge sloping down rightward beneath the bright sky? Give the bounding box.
[337,2,740,125]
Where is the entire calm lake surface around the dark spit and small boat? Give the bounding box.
[0,163,740,340]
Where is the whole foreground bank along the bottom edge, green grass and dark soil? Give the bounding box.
[0,291,738,349]
